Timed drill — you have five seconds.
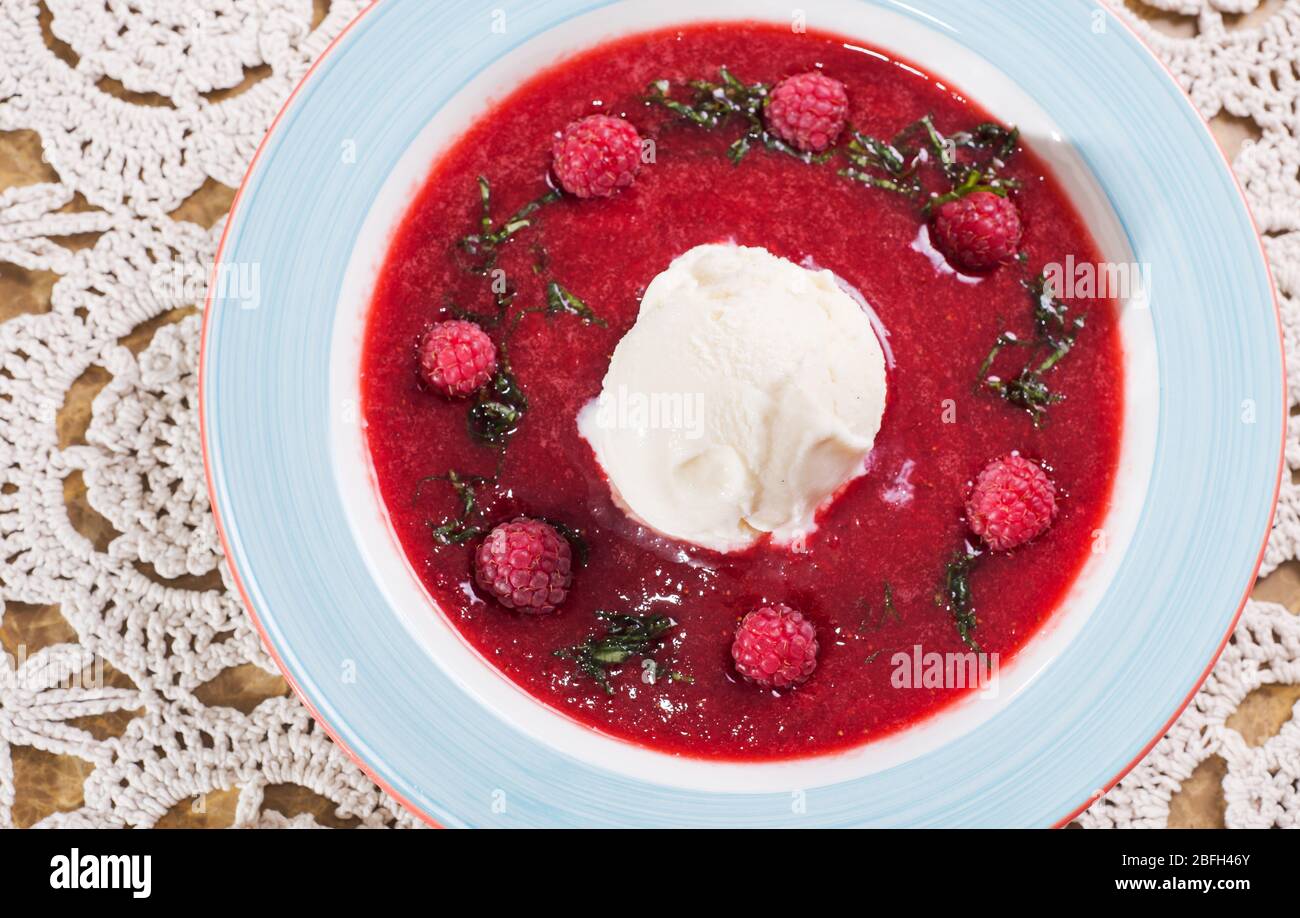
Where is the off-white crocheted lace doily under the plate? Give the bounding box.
[0,0,1300,827]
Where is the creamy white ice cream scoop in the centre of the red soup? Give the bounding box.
[579,244,885,551]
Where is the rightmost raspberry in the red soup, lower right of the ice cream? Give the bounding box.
[966,452,1057,551]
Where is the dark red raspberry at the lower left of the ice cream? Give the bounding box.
[475,516,573,615]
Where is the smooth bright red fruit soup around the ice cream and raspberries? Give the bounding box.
[363,23,1123,761]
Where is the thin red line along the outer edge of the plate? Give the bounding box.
[199,0,1290,828]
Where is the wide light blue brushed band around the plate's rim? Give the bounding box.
[202,0,1284,826]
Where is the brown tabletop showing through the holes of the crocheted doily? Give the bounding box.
[0,0,1300,827]
